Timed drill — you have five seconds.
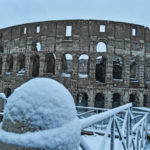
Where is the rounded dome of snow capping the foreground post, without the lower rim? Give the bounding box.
[4,78,76,129]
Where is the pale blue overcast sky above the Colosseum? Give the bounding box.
[0,0,150,28]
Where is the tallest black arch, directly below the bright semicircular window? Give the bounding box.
[95,56,106,83]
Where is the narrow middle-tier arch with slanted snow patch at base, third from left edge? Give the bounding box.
[18,54,25,74]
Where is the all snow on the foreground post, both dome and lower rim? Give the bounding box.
[0,78,81,149]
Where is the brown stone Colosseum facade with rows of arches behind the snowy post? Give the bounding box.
[0,20,150,108]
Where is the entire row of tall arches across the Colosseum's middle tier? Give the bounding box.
[0,53,150,83]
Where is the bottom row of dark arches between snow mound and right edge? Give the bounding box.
[77,92,146,108]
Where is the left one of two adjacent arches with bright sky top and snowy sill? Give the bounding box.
[62,53,73,77]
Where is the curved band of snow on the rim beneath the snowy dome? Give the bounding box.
[0,119,80,150]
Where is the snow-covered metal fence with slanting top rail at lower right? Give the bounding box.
[78,103,148,150]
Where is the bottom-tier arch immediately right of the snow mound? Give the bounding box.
[77,92,88,107]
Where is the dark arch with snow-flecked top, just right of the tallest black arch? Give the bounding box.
[113,56,123,79]
